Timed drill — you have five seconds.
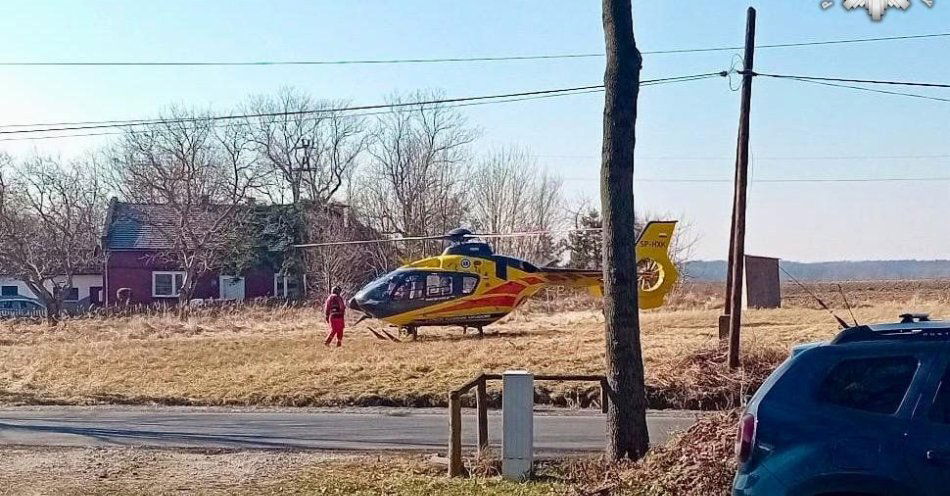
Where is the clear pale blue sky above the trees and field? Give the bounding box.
[0,0,950,261]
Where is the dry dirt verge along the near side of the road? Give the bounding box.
[0,448,568,496]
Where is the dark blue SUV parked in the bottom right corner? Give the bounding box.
[733,314,950,496]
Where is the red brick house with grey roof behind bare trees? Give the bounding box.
[102,199,299,305]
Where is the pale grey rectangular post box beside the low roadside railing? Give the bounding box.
[501,370,534,481]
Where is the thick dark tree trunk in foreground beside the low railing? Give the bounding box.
[600,0,649,460]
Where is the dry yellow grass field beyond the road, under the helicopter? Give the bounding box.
[0,281,950,409]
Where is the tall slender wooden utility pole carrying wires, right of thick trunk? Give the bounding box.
[728,7,755,369]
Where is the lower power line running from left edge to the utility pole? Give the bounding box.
[0,71,728,135]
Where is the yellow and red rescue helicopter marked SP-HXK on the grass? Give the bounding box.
[298,221,679,338]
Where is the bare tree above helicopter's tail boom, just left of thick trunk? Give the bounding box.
[469,147,564,262]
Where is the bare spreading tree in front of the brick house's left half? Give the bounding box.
[109,108,263,301]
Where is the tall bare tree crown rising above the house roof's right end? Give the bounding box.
[245,88,367,205]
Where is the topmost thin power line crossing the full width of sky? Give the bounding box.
[0,33,950,67]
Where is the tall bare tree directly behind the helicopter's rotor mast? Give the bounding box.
[354,91,476,256]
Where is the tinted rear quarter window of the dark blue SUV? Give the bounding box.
[818,356,919,415]
